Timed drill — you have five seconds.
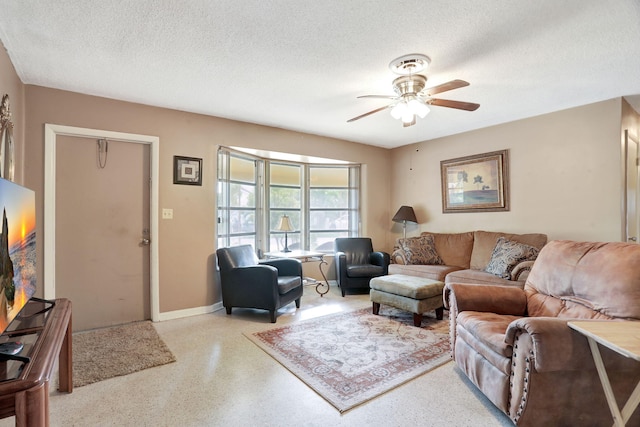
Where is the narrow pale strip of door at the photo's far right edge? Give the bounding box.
[625,131,640,243]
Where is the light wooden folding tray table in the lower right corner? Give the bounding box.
[568,320,640,427]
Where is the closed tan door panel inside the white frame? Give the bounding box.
[55,136,151,330]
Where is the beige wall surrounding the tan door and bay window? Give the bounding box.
[25,85,390,313]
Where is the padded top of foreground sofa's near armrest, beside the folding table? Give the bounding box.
[505,317,594,372]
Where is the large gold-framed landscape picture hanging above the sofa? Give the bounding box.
[440,150,509,213]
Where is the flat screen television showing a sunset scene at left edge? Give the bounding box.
[0,178,36,333]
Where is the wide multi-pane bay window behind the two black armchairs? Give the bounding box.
[217,147,360,254]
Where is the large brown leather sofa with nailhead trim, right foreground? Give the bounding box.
[444,241,640,426]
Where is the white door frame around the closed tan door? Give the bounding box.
[44,123,160,322]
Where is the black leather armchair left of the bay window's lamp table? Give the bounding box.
[216,245,302,323]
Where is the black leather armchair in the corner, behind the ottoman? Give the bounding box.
[333,237,390,296]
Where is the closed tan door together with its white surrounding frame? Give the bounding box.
[44,124,159,330]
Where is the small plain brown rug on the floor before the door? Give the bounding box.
[73,321,176,387]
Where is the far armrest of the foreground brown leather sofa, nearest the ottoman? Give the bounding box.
[443,283,527,316]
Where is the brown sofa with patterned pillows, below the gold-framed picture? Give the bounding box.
[389,230,547,288]
